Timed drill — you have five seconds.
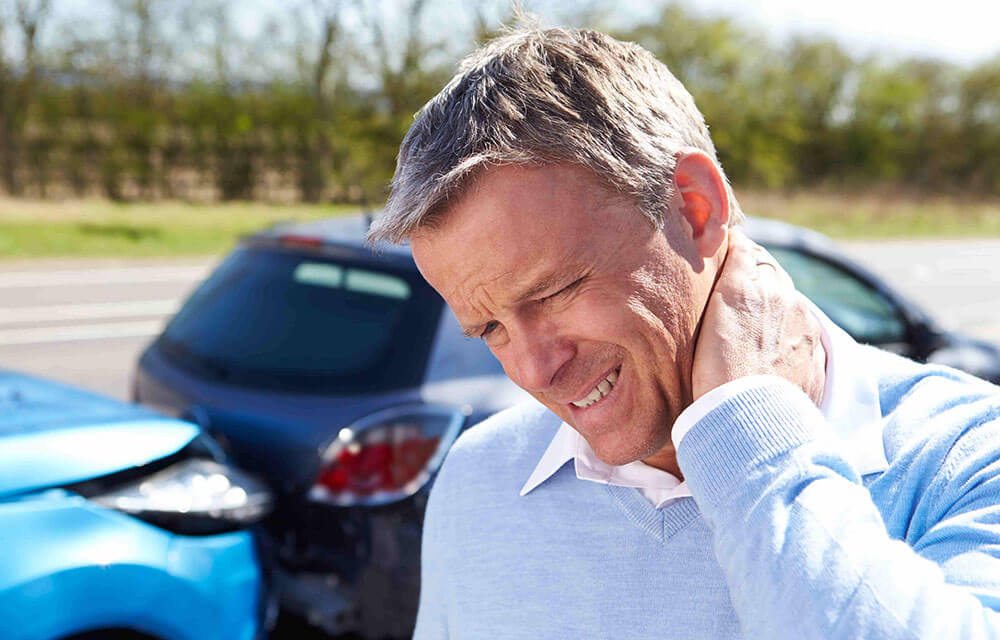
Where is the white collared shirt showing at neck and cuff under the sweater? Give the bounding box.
[521,306,888,509]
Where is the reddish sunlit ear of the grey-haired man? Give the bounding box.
[674,151,729,258]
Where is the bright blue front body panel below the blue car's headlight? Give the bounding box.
[0,489,262,640]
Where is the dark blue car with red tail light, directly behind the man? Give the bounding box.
[134,217,1000,638]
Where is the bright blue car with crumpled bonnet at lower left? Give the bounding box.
[0,371,273,640]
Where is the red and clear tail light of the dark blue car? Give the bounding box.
[309,405,466,505]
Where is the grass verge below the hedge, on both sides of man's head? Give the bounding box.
[0,189,1000,259]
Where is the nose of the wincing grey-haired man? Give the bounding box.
[508,325,575,392]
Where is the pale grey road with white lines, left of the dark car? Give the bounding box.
[0,259,214,399]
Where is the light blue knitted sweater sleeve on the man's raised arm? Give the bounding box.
[678,378,1000,640]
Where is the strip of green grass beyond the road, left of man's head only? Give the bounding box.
[0,200,357,259]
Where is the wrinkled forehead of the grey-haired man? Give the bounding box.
[411,165,651,313]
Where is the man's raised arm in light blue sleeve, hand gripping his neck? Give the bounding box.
[688,232,1000,640]
